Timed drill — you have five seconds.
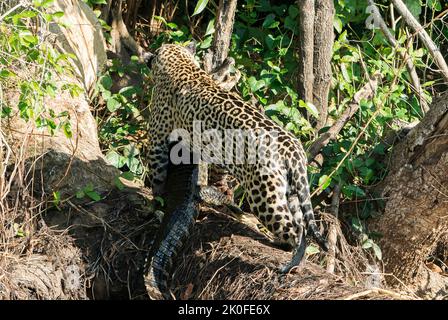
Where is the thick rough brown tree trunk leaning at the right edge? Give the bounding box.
[372,93,448,295]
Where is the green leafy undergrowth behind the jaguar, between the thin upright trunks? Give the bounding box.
[82,0,448,258]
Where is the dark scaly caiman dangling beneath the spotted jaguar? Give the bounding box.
[145,156,241,299]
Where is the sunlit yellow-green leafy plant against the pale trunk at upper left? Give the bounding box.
[0,0,82,138]
